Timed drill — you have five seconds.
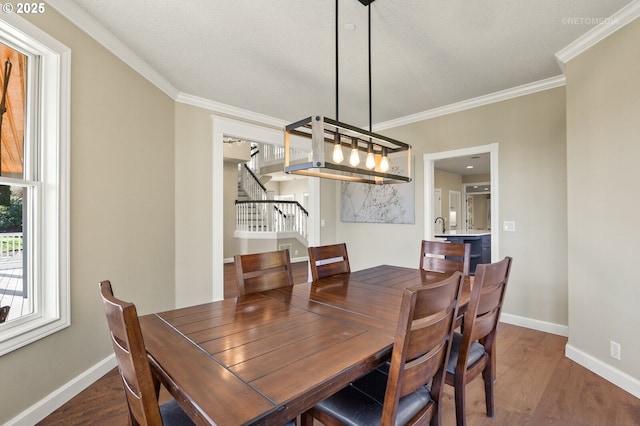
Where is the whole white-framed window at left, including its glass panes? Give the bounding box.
[0,14,71,355]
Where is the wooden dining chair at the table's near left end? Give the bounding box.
[100,281,194,426]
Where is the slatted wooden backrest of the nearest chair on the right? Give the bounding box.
[381,272,463,425]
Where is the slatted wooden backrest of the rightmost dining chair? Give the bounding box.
[456,257,512,374]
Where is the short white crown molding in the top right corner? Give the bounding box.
[556,0,640,68]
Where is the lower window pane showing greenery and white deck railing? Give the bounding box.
[0,185,33,321]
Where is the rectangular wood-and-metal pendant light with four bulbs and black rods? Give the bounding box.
[284,0,411,184]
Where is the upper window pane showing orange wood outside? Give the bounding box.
[0,43,27,179]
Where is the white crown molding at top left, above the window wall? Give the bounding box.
[47,0,179,99]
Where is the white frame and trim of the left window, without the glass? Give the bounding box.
[0,14,71,355]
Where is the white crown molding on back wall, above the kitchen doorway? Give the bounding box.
[373,75,566,131]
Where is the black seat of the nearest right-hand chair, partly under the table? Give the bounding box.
[316,364,431,426]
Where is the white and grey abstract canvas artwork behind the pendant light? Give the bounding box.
[340,159,415,224]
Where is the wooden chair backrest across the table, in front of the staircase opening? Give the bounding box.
[233,249,293,296]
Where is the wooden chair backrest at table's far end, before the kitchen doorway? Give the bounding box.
[420,240,471,275]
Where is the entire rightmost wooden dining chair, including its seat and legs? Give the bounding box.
[445,257,512,425]
